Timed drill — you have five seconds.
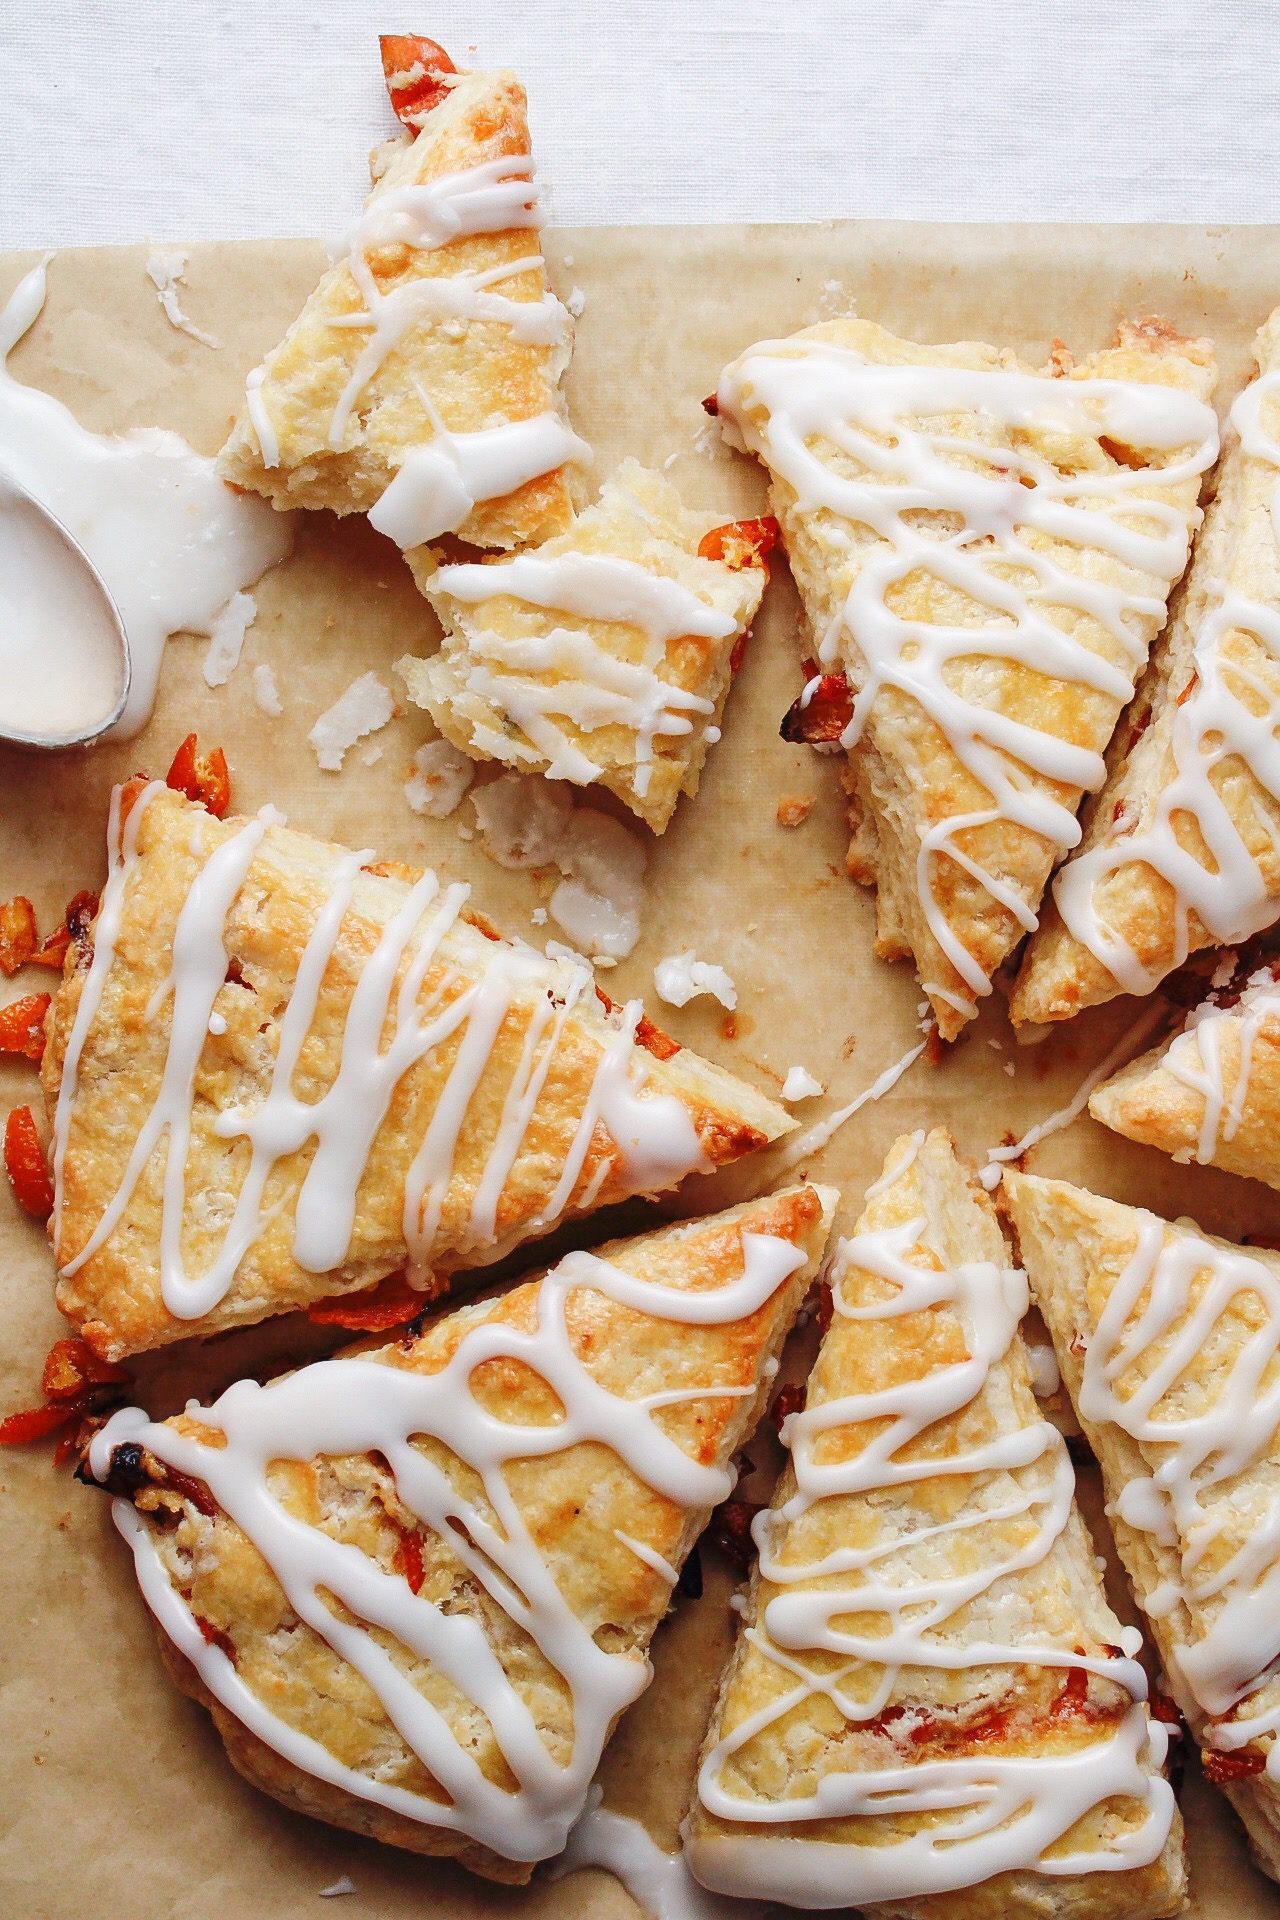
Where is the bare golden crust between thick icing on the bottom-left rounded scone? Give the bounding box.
[97,1187,837,1884]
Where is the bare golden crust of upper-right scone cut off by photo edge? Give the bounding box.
[1009,309,1280,1025]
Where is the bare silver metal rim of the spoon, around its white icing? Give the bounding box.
[0,468,132,751]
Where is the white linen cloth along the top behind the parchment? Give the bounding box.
[0,0,1280,248]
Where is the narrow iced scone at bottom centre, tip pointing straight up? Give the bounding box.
[687,1131,1184,1920]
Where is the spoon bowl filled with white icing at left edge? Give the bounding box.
[0,468,130,753]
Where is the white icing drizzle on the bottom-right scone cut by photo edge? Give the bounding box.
[1079,1213,1280,1780]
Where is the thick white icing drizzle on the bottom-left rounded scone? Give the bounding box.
[90,1231,804,1860]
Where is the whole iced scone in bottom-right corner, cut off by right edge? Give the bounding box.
[1004,1173,1280,1878]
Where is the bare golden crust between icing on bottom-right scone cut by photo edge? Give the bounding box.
[1004,1171,1280,1880]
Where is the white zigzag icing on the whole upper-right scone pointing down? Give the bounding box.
[720,340,1219,996]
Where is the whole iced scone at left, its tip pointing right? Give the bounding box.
[42,783,793,1357]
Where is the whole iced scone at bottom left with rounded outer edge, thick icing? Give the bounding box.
[90,1187,837,1882]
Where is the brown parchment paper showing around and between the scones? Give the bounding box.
[0,223,1280,1920]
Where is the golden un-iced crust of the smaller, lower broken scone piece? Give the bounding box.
[399,461,768,833]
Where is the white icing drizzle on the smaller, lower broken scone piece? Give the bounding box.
[432,553,737,799]
